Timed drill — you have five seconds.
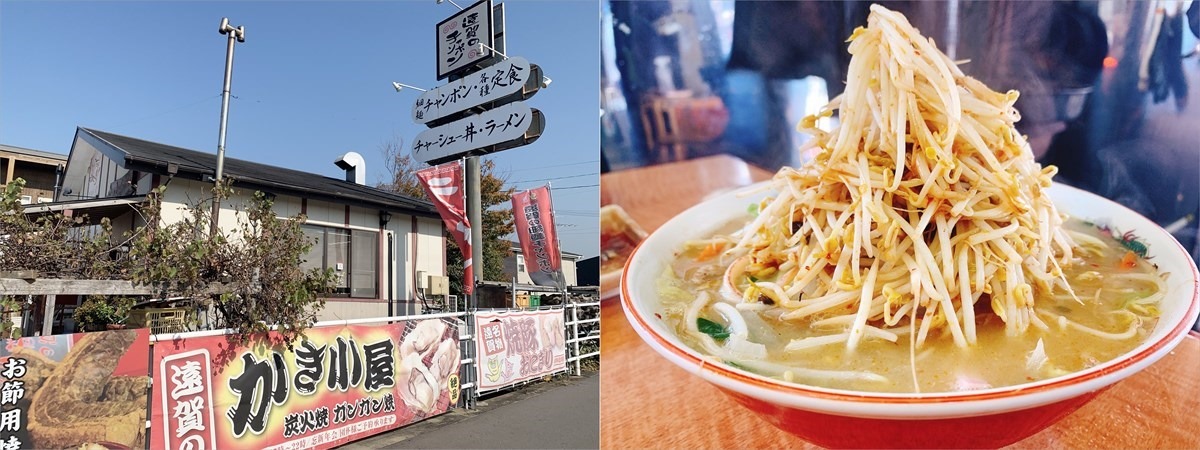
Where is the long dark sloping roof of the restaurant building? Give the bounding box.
[79,127,438,217]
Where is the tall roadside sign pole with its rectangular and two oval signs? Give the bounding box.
[415,0,550,311]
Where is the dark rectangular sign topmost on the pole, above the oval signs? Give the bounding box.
[436,0,496,79]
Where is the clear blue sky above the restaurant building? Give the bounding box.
[0,0,600,257]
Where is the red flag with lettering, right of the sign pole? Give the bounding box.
[512,186,563,287]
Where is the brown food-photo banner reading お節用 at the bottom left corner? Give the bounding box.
[0,329,150,450]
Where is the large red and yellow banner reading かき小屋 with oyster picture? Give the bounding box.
[150,319,461,449]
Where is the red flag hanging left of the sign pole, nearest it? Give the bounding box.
[416,161,475,294]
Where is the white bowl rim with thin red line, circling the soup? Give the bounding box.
[623,184,1200,418]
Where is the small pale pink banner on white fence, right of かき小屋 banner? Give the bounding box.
[475,310,566,391]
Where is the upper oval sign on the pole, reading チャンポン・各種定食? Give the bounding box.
[413,56,541,124]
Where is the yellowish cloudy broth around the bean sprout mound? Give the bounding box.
[659,220,1157,392]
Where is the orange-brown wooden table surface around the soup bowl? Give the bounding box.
[600,156,1200,449]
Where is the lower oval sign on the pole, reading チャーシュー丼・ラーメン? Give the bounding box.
[413,102,545,163]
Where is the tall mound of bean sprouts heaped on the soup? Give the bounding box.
[722,5,1074,349]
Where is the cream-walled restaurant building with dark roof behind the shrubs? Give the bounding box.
[38,127,445,320]
